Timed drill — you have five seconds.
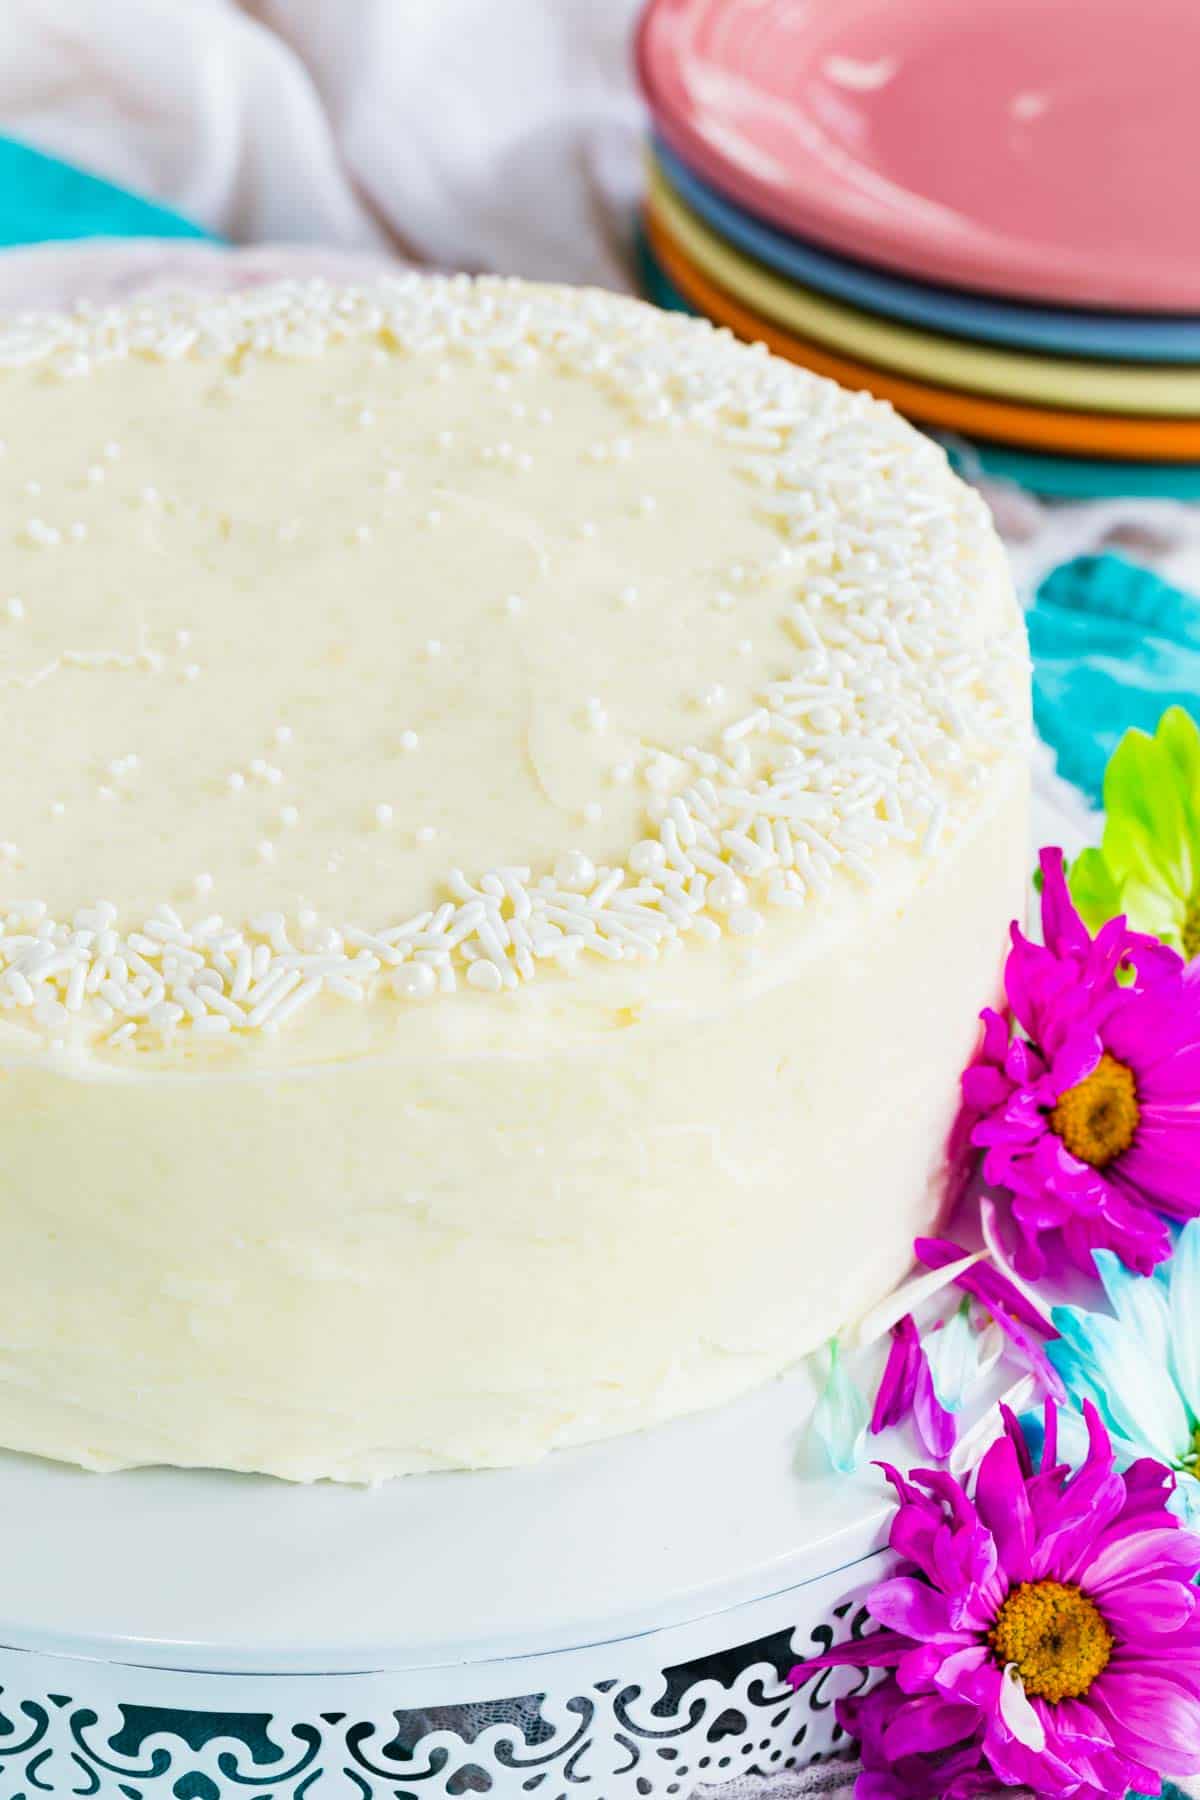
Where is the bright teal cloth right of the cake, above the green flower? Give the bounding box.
[1029,554,1200,805]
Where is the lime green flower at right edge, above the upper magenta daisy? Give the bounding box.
[1069,706,1200,959]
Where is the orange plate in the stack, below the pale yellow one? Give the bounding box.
[646,207,1200,463]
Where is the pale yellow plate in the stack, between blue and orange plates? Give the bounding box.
[649,158,1200,419]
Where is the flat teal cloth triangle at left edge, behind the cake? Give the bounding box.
[0,137,209,245]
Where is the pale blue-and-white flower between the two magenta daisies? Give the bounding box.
[1045,1219,1200,1528]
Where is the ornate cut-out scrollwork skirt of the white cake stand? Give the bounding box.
[0,1557,880,1800]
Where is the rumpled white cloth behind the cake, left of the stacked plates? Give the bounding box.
[0,0,642,286]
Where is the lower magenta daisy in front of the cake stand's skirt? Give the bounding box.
[792,1402,1200,1800]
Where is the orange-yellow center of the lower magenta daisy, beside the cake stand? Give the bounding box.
[988,1580,1112,1701]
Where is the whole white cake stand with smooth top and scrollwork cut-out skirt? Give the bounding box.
[0,1368,887,1800]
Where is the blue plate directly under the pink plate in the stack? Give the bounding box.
[655,139,1200,364]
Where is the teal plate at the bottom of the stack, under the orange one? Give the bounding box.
[637,232,1200,500]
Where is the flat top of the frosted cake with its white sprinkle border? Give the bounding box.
[0,275,1025,1048]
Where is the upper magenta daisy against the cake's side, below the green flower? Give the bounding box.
[963,850,1200,1278]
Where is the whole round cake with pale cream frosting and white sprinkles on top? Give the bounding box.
[0,275,1027,1481]
